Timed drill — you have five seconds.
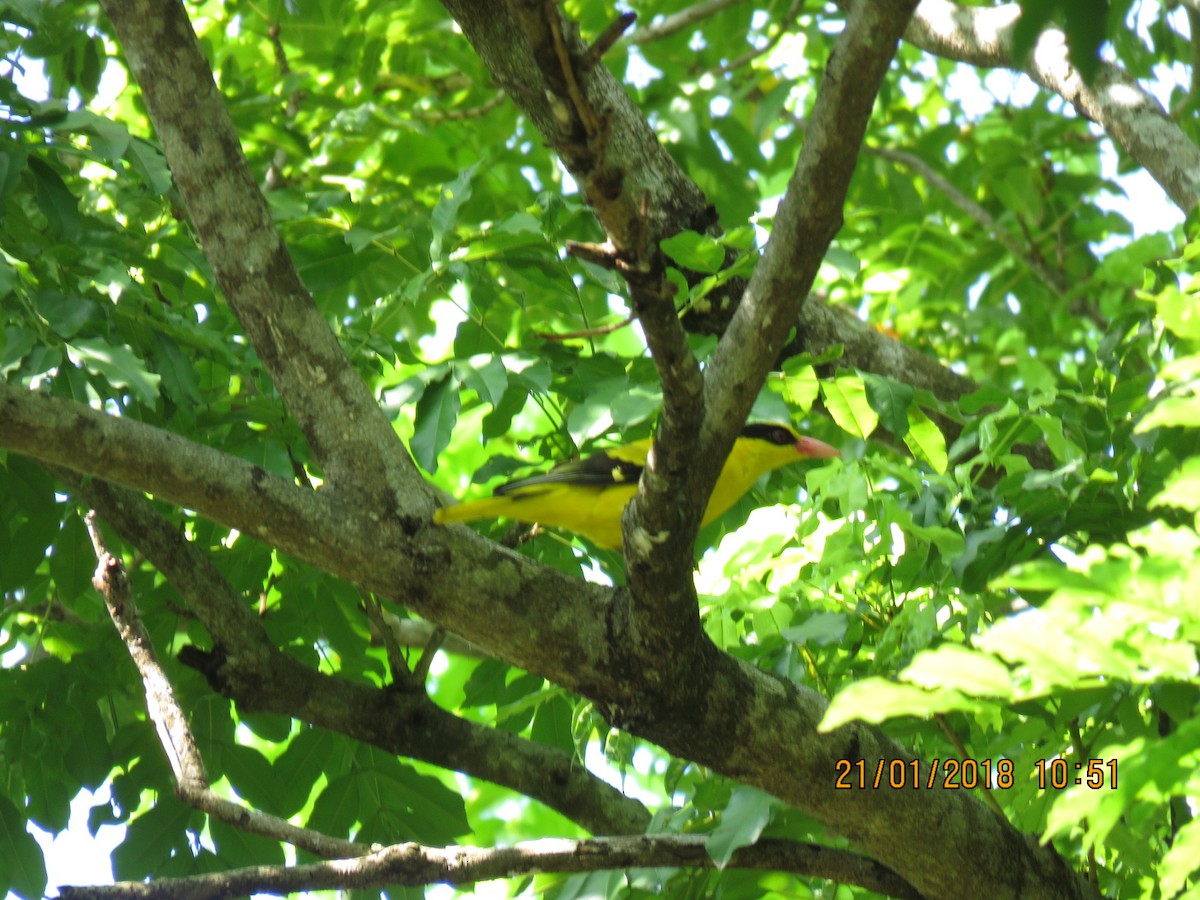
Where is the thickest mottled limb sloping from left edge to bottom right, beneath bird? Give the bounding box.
[0,357,1088,900]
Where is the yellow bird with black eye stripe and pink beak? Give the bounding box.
[433,422,841,550]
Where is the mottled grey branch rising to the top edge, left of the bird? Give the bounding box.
[103,0,432,518]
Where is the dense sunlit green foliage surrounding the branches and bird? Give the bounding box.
[0,0,1200,898]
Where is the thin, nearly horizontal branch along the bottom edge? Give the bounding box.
[61,835,920,900]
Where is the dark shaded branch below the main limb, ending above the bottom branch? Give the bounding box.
[74,481,649,840]
